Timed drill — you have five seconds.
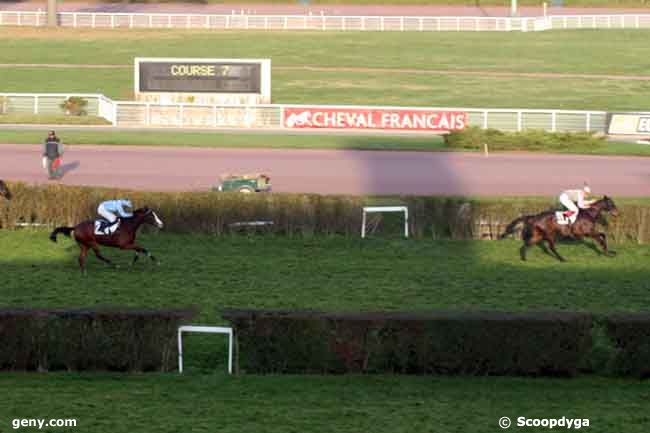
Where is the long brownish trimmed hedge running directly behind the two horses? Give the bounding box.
[0,184,650,243]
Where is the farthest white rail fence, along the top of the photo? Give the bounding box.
[0,11,650,32]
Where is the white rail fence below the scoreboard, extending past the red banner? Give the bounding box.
[0,93,607,132]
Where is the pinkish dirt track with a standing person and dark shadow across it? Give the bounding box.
[0,145,650,197]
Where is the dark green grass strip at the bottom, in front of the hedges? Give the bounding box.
[0,374,648,433]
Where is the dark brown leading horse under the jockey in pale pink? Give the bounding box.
[499,196,618,262]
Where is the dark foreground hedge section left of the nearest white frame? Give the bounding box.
[0,309,194,372]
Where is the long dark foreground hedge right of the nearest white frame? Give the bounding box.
[223,310,592,376]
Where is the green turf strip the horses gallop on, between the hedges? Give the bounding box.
[0,230,650,323]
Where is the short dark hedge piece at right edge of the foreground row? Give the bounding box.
[606,313,650,378]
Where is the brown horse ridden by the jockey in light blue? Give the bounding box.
[50,207,163,274]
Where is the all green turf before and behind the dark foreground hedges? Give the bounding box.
[0,230,650,433]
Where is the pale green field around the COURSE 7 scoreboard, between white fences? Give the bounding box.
[0,28,650,110]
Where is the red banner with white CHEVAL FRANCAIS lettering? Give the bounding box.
[284,107,467,132]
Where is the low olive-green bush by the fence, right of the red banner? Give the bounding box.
[445,126,604,151]
